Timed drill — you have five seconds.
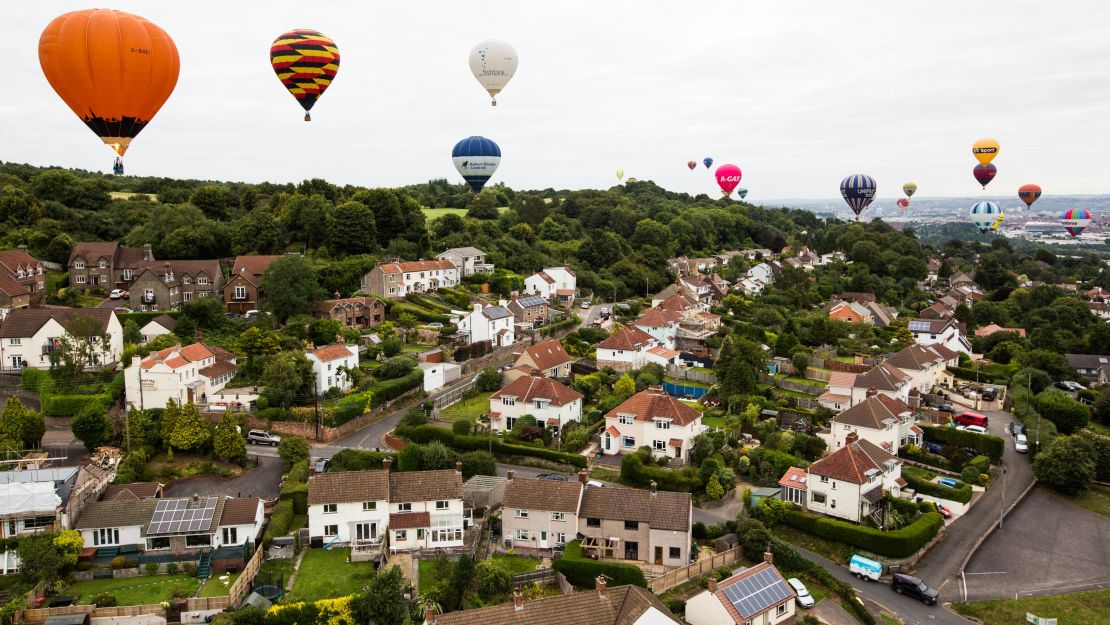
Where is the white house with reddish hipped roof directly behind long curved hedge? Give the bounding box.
[806,434,906,523]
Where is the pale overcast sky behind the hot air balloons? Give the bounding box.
[8,0,1110,202]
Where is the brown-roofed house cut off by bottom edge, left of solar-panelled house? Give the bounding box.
[422,577,682,625]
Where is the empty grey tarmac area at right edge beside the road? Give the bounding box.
[966,487,1110,601]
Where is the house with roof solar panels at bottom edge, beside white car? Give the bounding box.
[686,552,798,625]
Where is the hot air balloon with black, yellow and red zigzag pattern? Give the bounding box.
[270,28,340,121]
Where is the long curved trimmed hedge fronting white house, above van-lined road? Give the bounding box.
[783,510,945,557]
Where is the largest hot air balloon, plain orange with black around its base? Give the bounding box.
[39,9,180,173]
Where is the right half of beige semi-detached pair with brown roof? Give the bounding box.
[578,473,694,566]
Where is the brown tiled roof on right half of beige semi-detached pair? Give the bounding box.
[578,486,693,532]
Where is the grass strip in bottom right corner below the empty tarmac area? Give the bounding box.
[952,588,1110,625]
